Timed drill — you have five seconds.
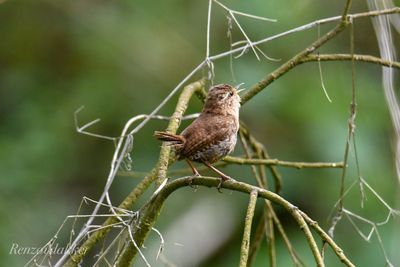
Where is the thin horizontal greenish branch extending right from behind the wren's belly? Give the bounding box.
[223,156,343,169]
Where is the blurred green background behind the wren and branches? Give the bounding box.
[0,0,400,266]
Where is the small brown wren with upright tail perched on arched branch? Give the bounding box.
[154,84,241,188]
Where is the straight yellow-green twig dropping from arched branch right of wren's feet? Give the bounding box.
[239,190,258,267]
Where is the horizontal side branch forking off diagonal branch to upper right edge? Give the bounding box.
[300,54,400,69]
